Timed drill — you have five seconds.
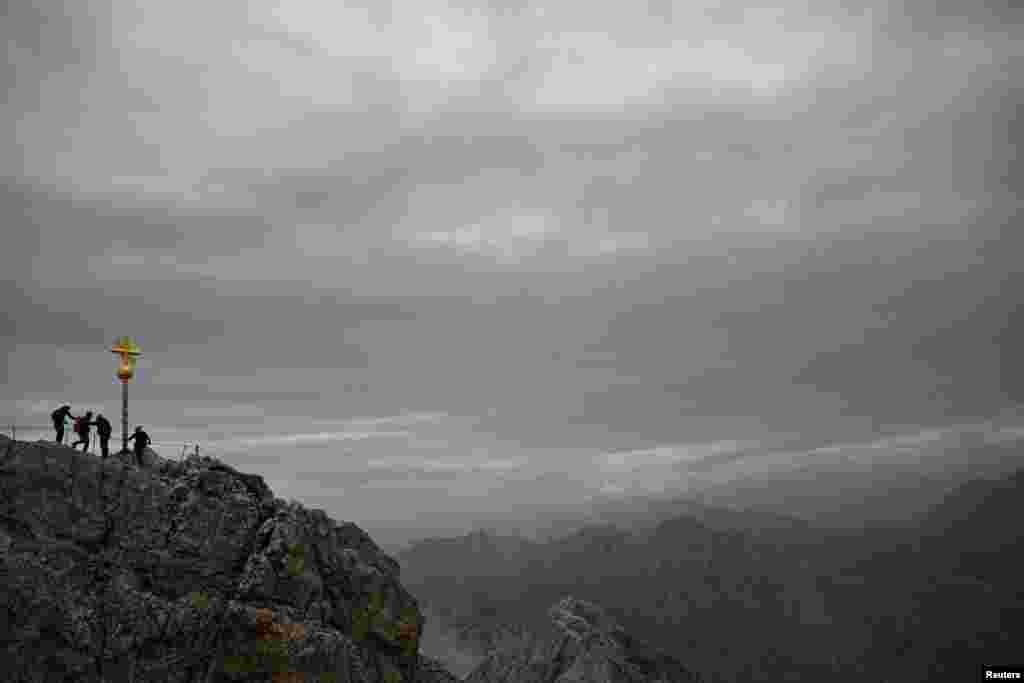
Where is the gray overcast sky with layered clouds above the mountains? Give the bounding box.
[0,0,1024,540]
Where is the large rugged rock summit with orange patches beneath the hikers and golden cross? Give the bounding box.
[0,436,455,683]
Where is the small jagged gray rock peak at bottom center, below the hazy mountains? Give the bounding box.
[465,597,700,683]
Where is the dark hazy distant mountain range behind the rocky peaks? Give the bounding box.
[397,464,1024,683]
